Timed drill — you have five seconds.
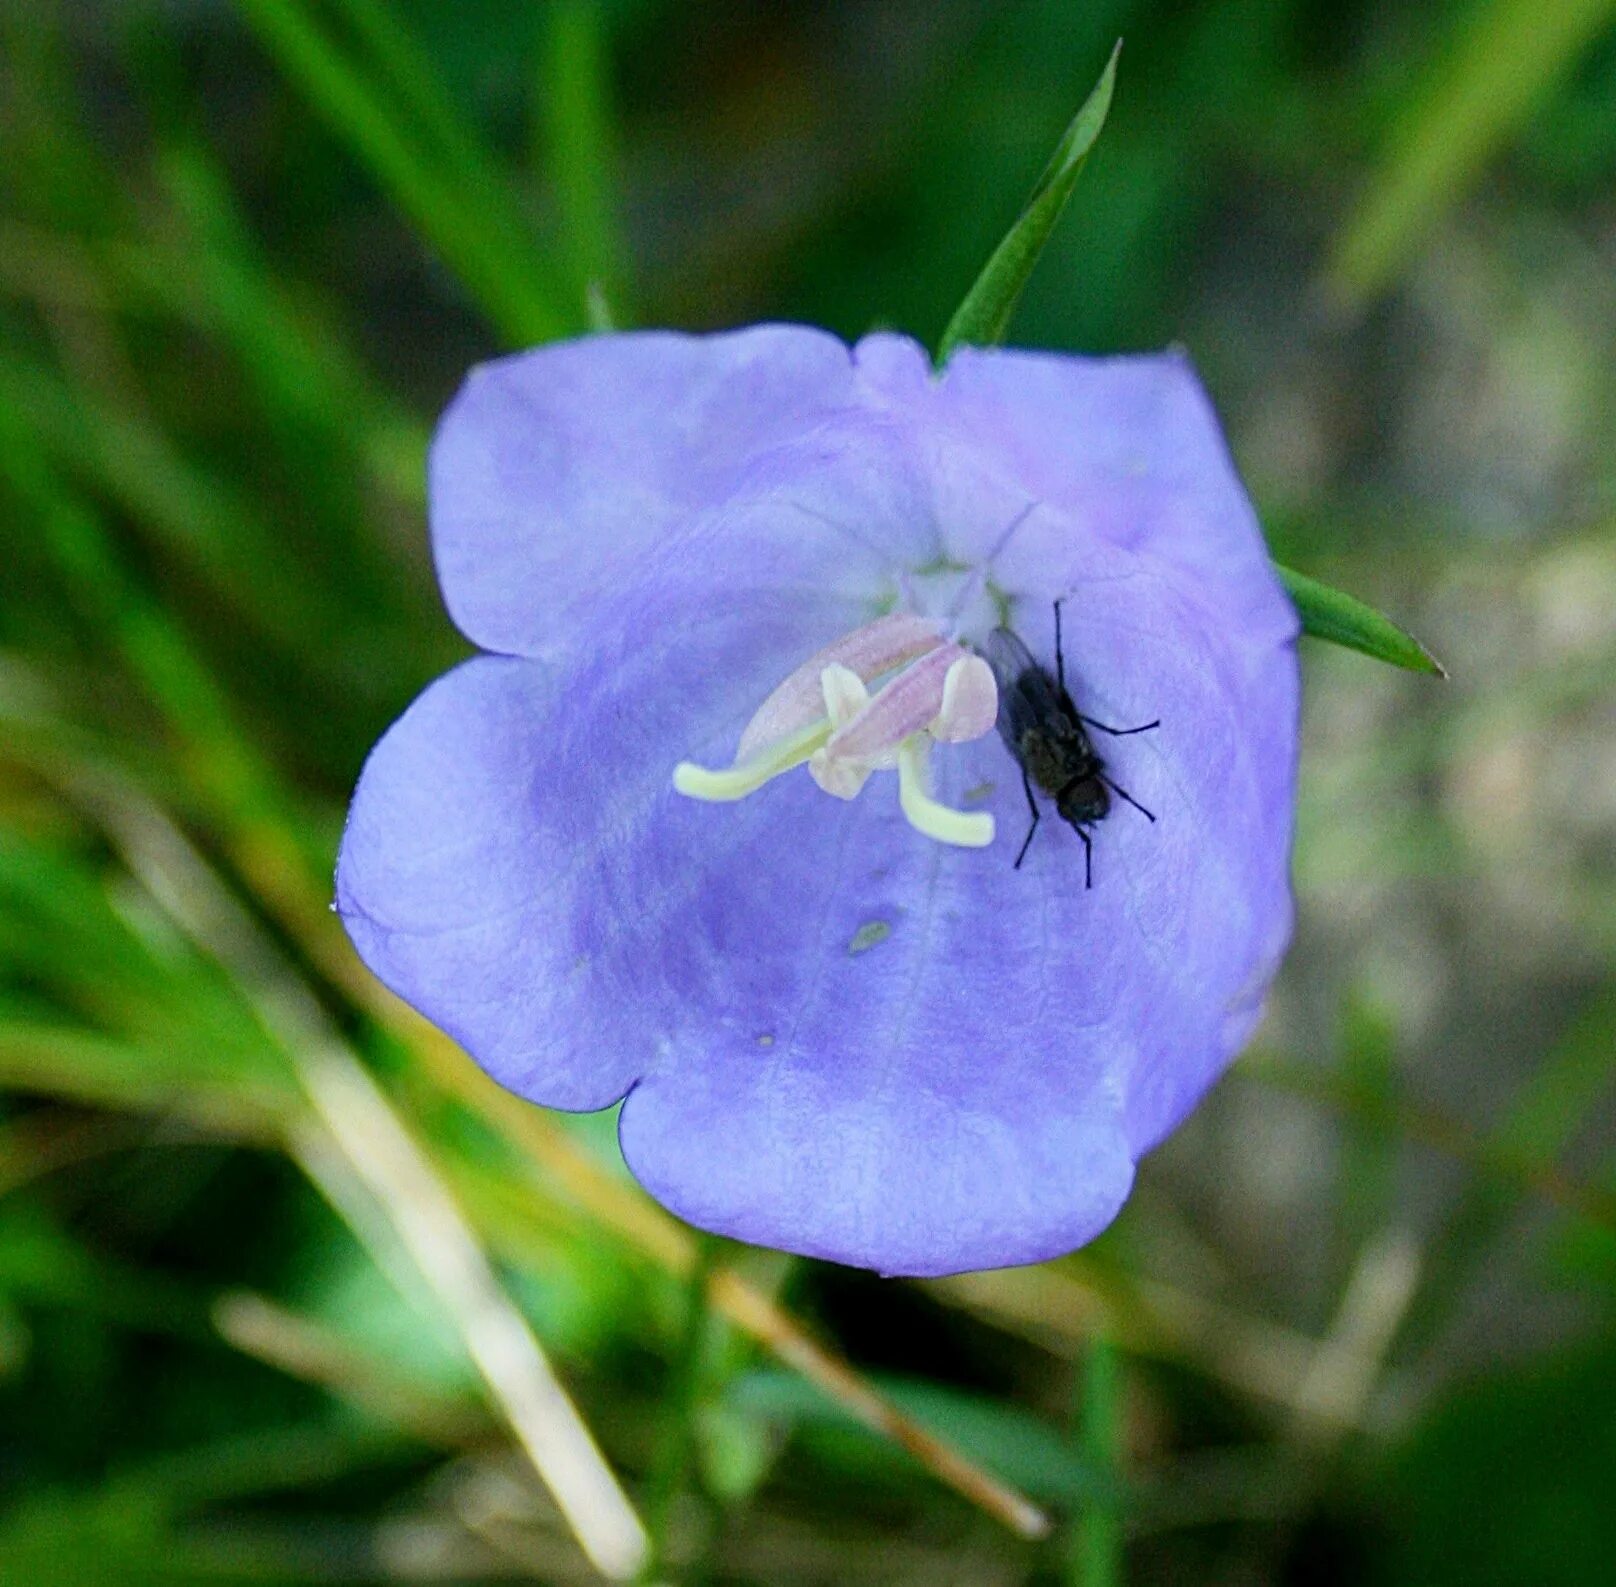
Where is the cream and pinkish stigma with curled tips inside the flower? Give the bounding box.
[674,612,999,848]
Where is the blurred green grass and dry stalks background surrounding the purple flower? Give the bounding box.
[0,0,1616,1587]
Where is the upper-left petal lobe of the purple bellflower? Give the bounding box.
[430,325,936,655]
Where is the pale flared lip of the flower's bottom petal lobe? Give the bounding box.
[619,1040,1133,1277]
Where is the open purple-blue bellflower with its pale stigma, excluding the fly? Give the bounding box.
[336,325,1298,1275]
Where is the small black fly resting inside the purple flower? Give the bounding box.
[986,601,1162,887]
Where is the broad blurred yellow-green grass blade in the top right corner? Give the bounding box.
[1325,0,1616,307]
